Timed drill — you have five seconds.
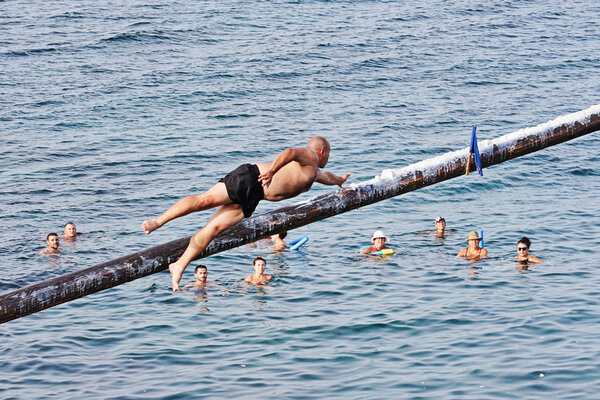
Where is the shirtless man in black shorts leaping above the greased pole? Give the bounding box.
[142,136,350,291]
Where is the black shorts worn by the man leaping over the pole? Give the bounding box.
[219,164,265,218]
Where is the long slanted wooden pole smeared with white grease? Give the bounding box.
[0,105,600,323]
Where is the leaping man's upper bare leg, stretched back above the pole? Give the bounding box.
[142,182,231,235]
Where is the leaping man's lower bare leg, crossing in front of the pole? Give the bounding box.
[169,204,244,291]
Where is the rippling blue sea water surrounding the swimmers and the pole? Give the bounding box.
[0,0,600,399]
